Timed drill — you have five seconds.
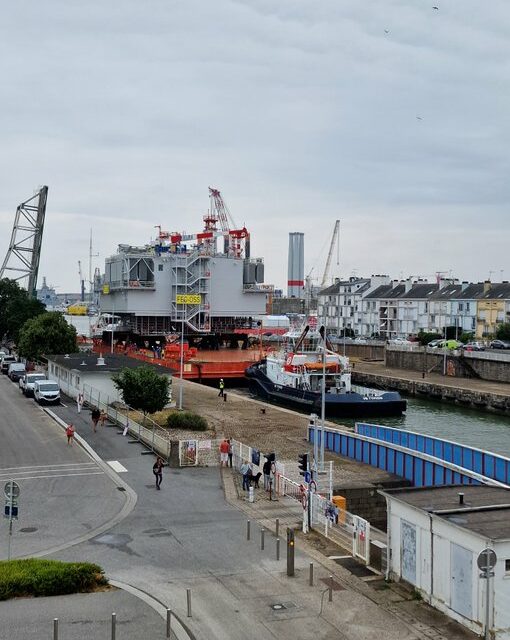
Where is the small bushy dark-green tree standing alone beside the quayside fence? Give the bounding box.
[112,366,170,420]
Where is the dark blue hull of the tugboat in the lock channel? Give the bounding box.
[245,364,407,418]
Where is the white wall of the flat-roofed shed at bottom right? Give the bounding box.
[388,499,510,640]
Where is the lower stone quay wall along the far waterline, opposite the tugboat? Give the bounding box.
[352,370,510,414]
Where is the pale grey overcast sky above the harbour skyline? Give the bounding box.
[0,0,510,291]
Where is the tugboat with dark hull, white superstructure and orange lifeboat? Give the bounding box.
[245,325,407,418]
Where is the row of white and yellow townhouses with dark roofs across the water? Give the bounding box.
[317,275,510,339]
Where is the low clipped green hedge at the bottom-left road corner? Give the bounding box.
[0,558,108,600]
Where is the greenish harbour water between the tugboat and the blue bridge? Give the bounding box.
[333,398,510,457]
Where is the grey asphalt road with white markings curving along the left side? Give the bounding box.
[0,375,126,559]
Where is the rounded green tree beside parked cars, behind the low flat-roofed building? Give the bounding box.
[18,311,77,360]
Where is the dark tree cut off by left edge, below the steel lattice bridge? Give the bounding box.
[0,278,45,342]
